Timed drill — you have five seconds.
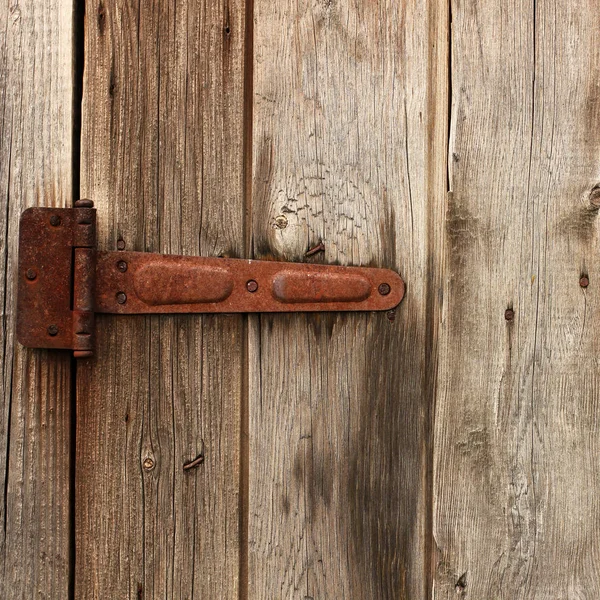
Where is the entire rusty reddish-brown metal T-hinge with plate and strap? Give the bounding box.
[17,200,404,358]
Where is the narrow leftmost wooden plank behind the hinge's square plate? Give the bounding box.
[0,0,73,599]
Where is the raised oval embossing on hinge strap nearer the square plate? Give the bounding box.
[134,263,233,306]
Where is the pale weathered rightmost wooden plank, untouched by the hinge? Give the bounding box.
[434,0,600,599]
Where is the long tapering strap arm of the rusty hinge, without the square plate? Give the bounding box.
[96,252,404,314]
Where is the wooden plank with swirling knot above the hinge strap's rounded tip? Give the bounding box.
[248,0,447,600]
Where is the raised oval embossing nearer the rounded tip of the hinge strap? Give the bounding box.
[273,271,371,304]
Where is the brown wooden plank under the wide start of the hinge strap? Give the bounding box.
[75,0,245,599]
